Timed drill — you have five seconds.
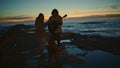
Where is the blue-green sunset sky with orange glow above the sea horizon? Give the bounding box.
[0,0,120,23]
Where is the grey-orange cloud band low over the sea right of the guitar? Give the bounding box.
[66,14,120,21]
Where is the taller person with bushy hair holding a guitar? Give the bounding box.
[48,9,63,44]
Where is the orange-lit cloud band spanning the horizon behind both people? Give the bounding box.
[0,10,120,23]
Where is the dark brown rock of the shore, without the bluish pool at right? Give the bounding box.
[0,25,120,68]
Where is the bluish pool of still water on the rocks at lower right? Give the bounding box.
[66,42,120,68]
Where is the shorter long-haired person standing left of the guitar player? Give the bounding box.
[35,13,46,54]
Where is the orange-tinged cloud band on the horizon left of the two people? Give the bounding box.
[0,15,34,23]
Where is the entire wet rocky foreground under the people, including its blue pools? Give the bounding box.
[0,25,120,68]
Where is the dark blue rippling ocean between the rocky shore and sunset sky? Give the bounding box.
[0,20,120,37]
